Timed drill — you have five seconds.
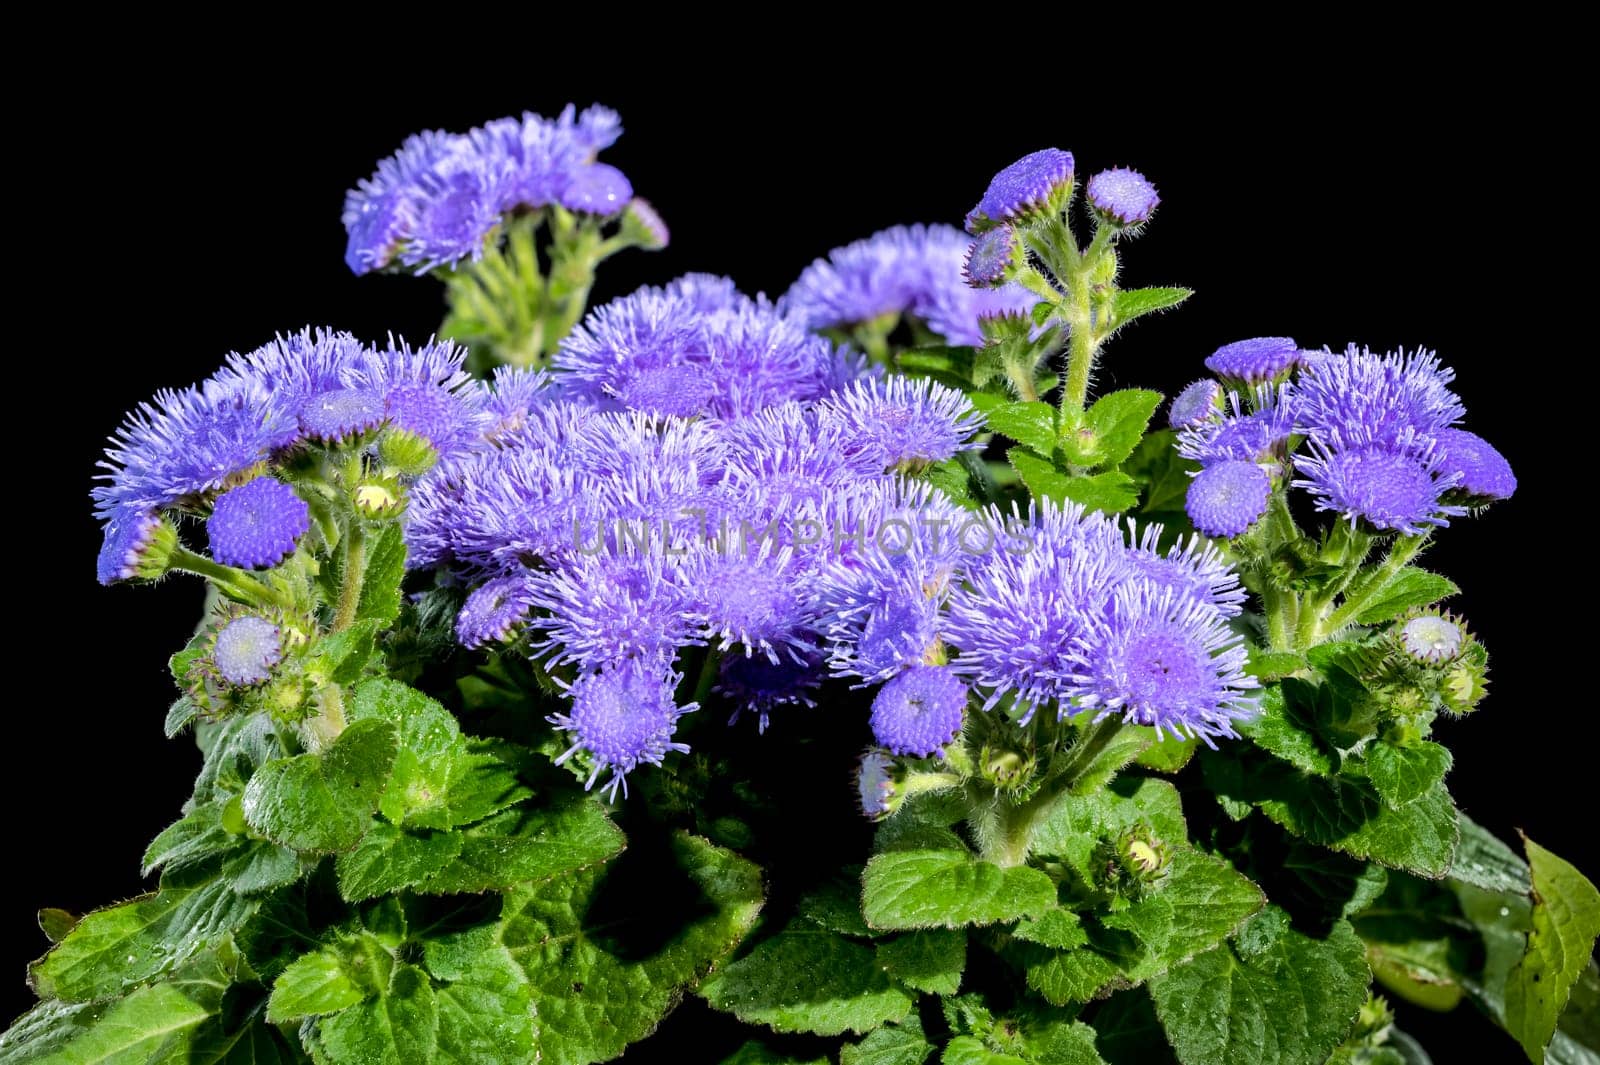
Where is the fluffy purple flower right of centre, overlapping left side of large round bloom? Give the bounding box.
[944,501,1132,721]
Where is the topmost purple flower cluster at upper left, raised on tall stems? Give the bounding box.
[344,106,643,273]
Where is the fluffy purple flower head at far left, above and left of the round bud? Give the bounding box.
[93,377,298,517]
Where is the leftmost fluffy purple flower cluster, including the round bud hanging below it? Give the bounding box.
[93,329,488,584]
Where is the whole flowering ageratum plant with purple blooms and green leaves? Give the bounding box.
[0,107,1600,1065]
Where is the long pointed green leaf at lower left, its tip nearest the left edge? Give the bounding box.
[29,880,256,1003]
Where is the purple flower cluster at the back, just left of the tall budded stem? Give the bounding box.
[779,223,1030,344]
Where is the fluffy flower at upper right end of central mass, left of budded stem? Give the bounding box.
[818,376,984,472]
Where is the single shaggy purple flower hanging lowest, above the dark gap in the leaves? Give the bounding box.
[549,659,699,801]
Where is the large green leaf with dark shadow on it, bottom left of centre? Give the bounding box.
[499,833,762,1065]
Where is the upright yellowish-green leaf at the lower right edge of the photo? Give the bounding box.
[1506,836,1600,1062]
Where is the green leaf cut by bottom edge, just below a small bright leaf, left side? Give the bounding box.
[301,964,438,1065]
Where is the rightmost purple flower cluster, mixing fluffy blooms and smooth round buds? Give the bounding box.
[1171,337,1517,537]
